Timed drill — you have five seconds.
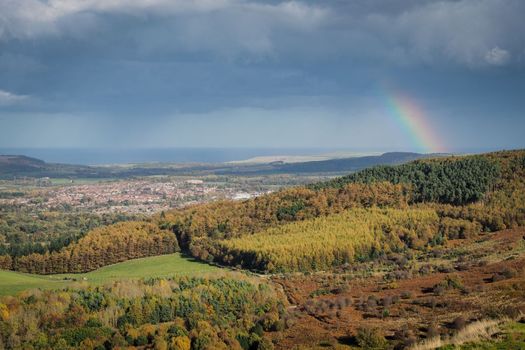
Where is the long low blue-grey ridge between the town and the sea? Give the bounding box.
[0,152,446,179]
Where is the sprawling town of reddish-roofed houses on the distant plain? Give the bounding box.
[0,177,275,214]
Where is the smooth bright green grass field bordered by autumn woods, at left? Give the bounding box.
[0,253,219,295]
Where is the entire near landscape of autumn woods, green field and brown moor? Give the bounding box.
[0,150,525,350]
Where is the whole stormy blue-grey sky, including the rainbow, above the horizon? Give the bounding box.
[0,0,525,152]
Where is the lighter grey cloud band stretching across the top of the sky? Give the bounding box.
[0,0,525,67]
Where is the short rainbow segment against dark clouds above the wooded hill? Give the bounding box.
[386,92,446,153]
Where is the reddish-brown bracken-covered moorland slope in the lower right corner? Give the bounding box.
[272,228,525,350]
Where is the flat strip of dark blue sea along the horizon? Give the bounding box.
[0,148,346,165]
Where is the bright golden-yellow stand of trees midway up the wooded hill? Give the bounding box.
[218,209,440,273]
